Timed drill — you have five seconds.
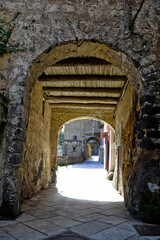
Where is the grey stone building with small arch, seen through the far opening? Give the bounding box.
[58,119,100,164]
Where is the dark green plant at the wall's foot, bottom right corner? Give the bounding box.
[139,190,160,224]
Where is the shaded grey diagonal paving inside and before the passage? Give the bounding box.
[0,160,160,240]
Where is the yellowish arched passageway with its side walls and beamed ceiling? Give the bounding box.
[0,41,159,224]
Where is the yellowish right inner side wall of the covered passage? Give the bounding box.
[113,83,134,195]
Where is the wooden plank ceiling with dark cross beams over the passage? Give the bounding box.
[39,58,127,116]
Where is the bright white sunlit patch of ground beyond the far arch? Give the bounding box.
[57,159,123,202]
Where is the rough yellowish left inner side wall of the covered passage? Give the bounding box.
[19,83,51,201]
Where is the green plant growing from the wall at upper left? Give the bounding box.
[0,12,24,55]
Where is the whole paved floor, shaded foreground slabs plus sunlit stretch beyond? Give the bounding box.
[0,159,160,240]
